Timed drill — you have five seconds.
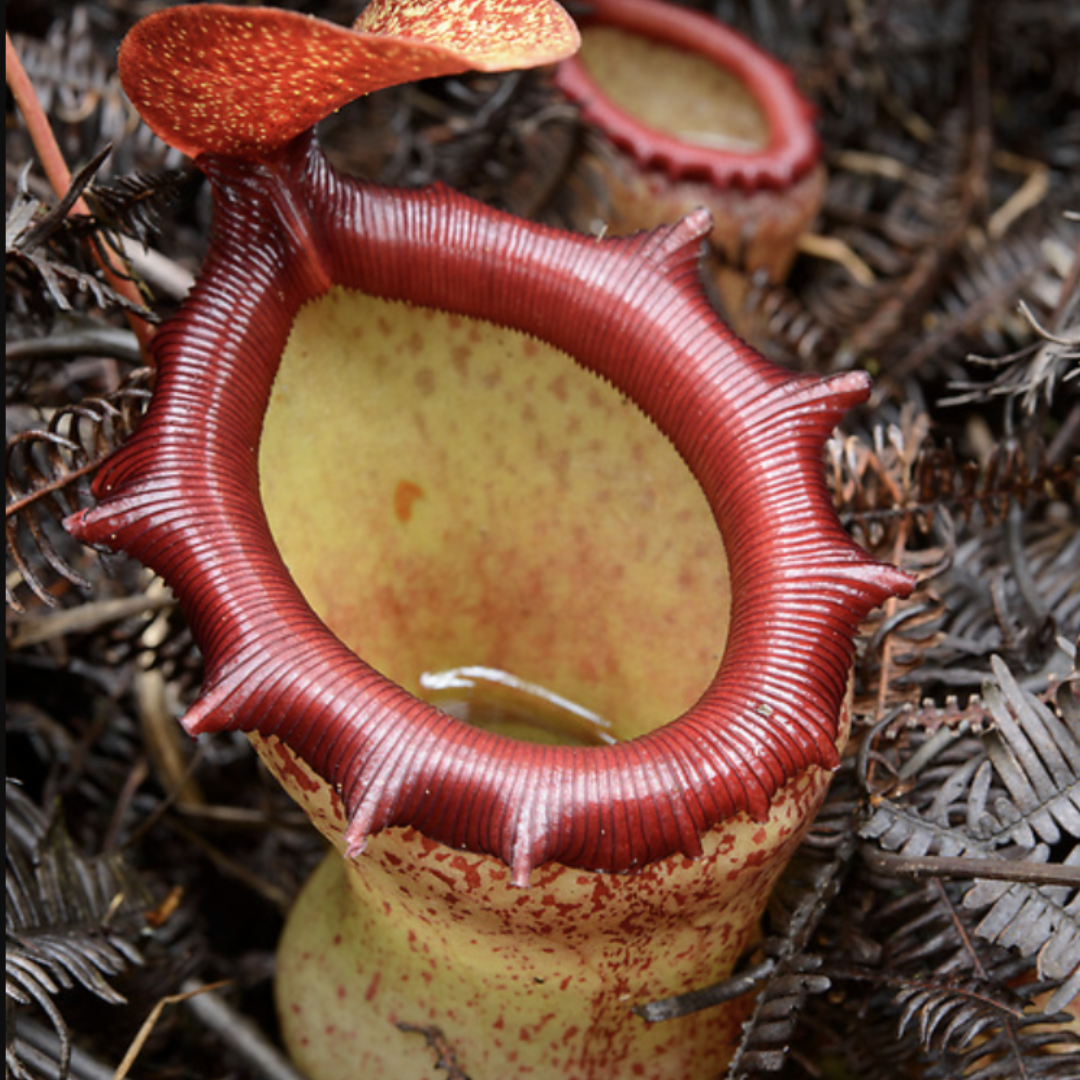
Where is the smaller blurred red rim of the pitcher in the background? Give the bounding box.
[555,0,821,191]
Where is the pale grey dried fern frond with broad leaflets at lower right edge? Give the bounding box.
[861,658,1080,1012]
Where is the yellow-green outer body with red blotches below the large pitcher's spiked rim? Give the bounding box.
[256,715,847,1080]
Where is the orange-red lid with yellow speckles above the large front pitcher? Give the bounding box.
[119,0,578,160]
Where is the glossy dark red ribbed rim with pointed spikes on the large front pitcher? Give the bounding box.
[69,132,912,885]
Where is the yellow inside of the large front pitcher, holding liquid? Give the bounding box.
[259,288,730,745]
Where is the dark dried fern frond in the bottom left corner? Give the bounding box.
[5,782,149,1078]
